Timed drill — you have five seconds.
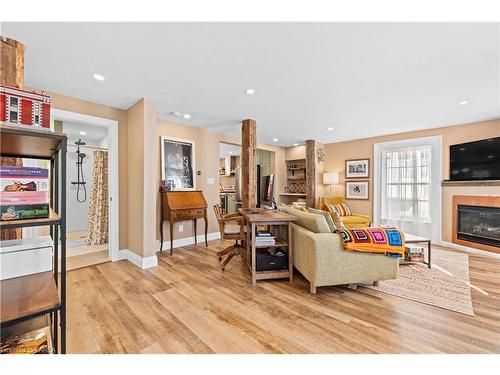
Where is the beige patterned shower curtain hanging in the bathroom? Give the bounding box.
[86,150,109,246]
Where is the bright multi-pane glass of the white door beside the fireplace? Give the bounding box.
[381,145,432,222]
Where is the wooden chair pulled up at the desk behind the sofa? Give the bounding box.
[214,204,246,271]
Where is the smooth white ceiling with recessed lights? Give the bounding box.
[2,23,500,146]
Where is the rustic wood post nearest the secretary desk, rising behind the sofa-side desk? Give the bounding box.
[241,119,257,208]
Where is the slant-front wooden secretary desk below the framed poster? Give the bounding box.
[160,189,208,255]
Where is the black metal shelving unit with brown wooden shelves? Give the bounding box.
[0,126,67,354]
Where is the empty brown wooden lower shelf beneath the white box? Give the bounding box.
[0,272,61,323]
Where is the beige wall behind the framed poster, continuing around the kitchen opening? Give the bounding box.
[155,119,286,241]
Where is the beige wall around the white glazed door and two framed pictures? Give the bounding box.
[324,120,500,239]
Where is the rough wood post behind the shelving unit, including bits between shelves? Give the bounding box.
[0,35,24,240]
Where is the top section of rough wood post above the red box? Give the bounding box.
[0,36,24,89]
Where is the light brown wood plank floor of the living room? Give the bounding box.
[67,241,500,353]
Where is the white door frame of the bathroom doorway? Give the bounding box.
[50,108,120,262]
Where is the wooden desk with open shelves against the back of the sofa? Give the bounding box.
[239,208,297,286]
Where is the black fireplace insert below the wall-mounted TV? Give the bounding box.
[457,204,500,247]
